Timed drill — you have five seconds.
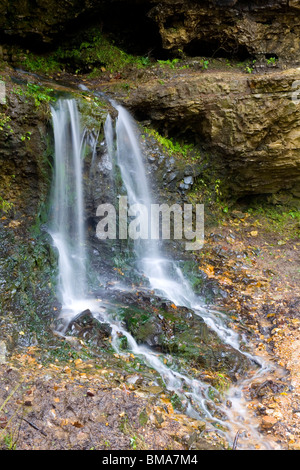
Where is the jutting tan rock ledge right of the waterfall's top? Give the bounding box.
[118,66,300,195]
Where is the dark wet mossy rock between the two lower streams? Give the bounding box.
[116,296,253,381]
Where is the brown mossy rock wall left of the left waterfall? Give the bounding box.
[0,72,51,217]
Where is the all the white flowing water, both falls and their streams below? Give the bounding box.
[49,100,280,449]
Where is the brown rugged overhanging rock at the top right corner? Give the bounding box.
[149,0,300,61]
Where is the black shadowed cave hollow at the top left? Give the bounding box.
[0,1,166,59]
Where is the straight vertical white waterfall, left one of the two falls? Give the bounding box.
[49,100,86,320]
